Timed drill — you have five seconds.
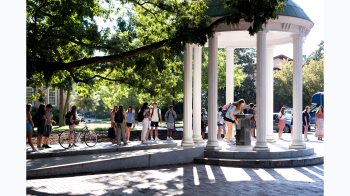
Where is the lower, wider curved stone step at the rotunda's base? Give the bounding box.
[194,153,323,168]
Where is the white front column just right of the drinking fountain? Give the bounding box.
[253,31,272,151]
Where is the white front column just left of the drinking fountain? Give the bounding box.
[205,33,221,150]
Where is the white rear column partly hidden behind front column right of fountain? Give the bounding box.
[265,46,276,143]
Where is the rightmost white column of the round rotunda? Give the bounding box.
[289,35,306,149]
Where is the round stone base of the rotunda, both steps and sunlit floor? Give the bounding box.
[194,136,324,168]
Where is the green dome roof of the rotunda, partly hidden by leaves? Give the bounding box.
[206,0,312,22]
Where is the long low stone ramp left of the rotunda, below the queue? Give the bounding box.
[27,147,204,179]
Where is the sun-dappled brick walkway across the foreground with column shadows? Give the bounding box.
[26,164,324,196]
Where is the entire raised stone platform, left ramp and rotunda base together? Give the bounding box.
[27,134,323,179]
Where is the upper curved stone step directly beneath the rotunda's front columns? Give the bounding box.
[204,148,314,159]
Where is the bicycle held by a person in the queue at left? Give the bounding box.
[58,121,97,149]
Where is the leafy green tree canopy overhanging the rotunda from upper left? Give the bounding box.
[26,0,284,94]
